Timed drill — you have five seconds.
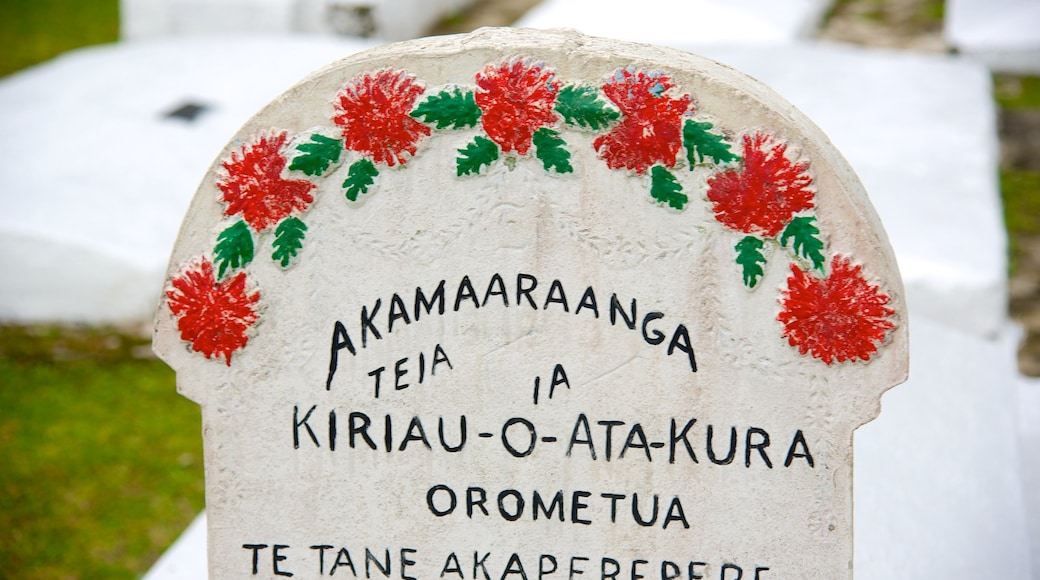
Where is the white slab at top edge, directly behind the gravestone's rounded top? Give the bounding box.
[516,0,831,46]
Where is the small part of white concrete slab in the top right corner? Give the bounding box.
[943,0,1040,74]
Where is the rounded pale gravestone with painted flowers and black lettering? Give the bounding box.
[155,30,907,580]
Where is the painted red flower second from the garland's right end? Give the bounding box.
[707,133,813,237]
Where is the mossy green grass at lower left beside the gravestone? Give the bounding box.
[0,326,204,580]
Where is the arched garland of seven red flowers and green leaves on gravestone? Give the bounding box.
[165,57,895,366]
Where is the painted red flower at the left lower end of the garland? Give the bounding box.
[166,258,260,367]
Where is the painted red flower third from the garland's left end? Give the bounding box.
[332,69,430,167]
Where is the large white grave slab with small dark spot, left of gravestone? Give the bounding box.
[0,38,371,323]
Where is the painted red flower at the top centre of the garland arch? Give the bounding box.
[475,58,560,155]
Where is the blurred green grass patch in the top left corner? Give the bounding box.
[0,0,120,76]
